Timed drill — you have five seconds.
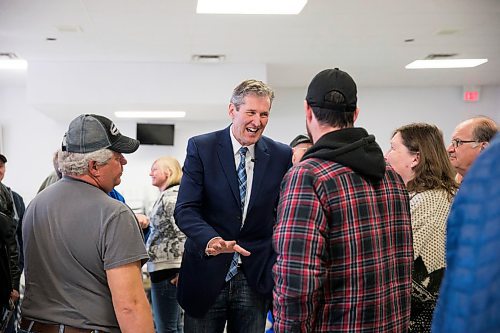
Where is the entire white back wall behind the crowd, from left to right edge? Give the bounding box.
[0,84,500,206]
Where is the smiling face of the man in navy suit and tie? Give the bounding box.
[229,94,271,146]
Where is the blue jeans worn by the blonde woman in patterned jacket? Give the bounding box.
[151,279,186,333]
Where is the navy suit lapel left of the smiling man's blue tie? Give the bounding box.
[217,127,241,204]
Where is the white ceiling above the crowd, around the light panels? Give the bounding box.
[0,0,500,118]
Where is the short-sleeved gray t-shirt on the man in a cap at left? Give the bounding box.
[22,177,148,332]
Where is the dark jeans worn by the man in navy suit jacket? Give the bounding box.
[184,271,270,333]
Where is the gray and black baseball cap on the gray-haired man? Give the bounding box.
[62,114,140,154]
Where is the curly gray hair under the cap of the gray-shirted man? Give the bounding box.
[57,148,113,176]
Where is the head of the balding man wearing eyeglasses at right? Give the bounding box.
[448,116,498,178]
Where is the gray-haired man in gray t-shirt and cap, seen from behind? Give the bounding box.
[21,115,154,333]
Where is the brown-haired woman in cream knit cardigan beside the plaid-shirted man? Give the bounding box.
[385,123,457,332]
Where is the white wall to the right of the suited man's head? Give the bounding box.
[266,86,500,150]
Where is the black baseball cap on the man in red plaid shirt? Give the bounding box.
[306,68,358,112]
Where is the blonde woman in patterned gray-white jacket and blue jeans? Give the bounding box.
[146,156,186,333]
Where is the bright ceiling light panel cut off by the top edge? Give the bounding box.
[196,0,307,15]
